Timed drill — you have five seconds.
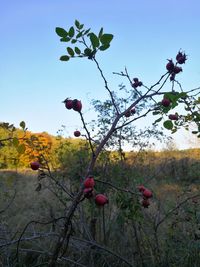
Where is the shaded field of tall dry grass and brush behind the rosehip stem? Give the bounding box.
[0,154,200,267]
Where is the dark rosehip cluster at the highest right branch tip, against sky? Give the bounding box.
[166,51,187,81]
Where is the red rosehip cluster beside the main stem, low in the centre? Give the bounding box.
[83,176,108,206]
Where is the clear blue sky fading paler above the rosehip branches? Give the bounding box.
[0,0,200,150]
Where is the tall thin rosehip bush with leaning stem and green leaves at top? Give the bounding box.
[47,20,200,267]
